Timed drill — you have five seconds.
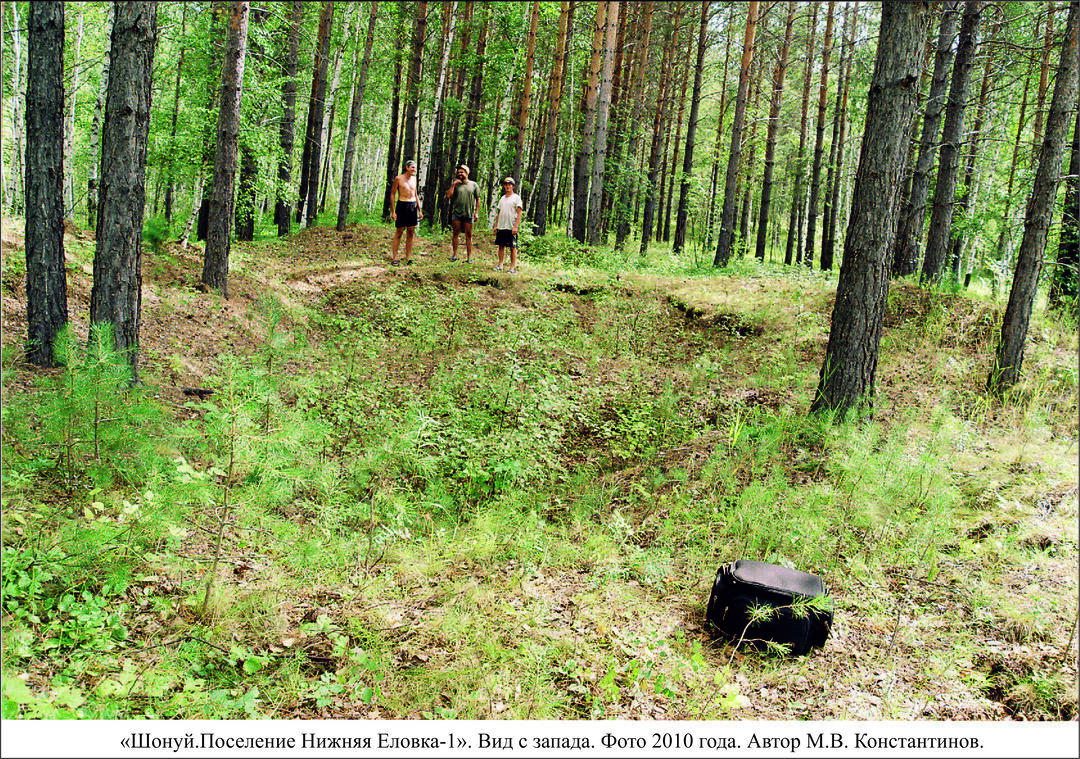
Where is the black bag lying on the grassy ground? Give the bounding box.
[705,559,833,656]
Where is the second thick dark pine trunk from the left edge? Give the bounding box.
[90,2,158,382]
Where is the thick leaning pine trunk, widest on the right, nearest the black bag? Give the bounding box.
[810,0,930,416]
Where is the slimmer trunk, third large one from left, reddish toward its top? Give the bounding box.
[202,0,247,298]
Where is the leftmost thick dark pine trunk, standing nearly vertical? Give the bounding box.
[23,2,68,366]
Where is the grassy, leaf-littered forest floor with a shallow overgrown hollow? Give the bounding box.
[2,214,1080,720]
